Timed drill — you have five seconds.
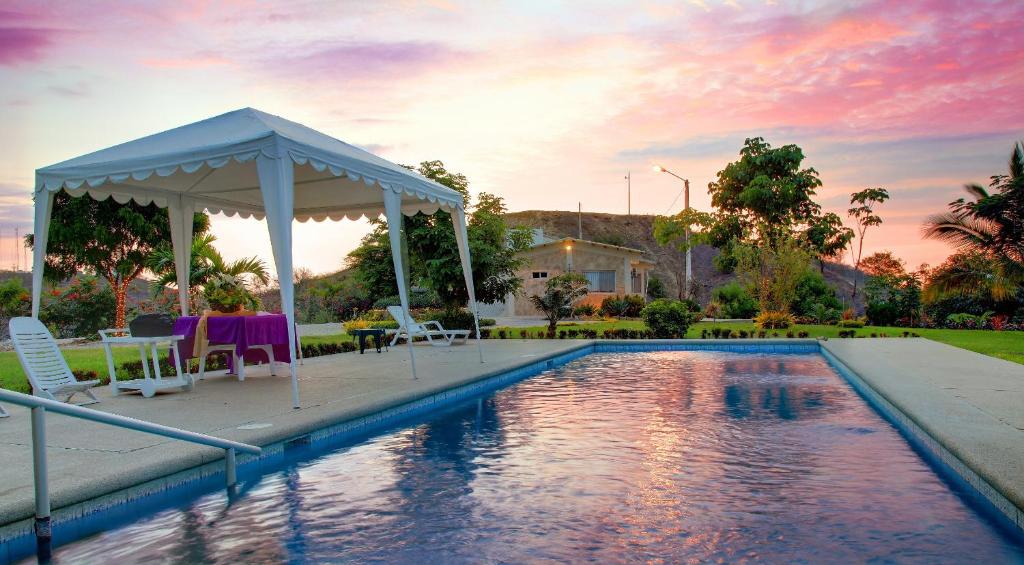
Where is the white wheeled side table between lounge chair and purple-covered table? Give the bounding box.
[99,329,196,398]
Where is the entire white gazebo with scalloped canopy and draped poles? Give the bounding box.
[32,108,483,408]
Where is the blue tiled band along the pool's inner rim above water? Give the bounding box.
[0,339,1024,561]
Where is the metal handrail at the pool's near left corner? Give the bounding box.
[0,389,262,554]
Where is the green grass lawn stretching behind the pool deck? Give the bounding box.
[0,320,1024,392]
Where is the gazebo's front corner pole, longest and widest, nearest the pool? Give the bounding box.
[256,155,301,408]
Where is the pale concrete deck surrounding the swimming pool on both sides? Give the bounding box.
[0,339,1024,539]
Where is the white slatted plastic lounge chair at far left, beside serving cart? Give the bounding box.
[9,317,99,406]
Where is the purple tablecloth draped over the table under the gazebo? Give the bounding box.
[174,314,292,363]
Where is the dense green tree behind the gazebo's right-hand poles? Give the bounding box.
[348,161,530,310]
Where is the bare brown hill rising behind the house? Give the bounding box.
[505,210,853,303]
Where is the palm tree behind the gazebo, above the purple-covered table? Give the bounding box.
[148,233,270,307]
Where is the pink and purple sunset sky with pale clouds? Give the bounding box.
[0,0,1024,272]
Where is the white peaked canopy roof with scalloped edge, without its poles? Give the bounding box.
[36,107,463,221]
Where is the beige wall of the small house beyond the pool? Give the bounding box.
[508,244,646,316]
